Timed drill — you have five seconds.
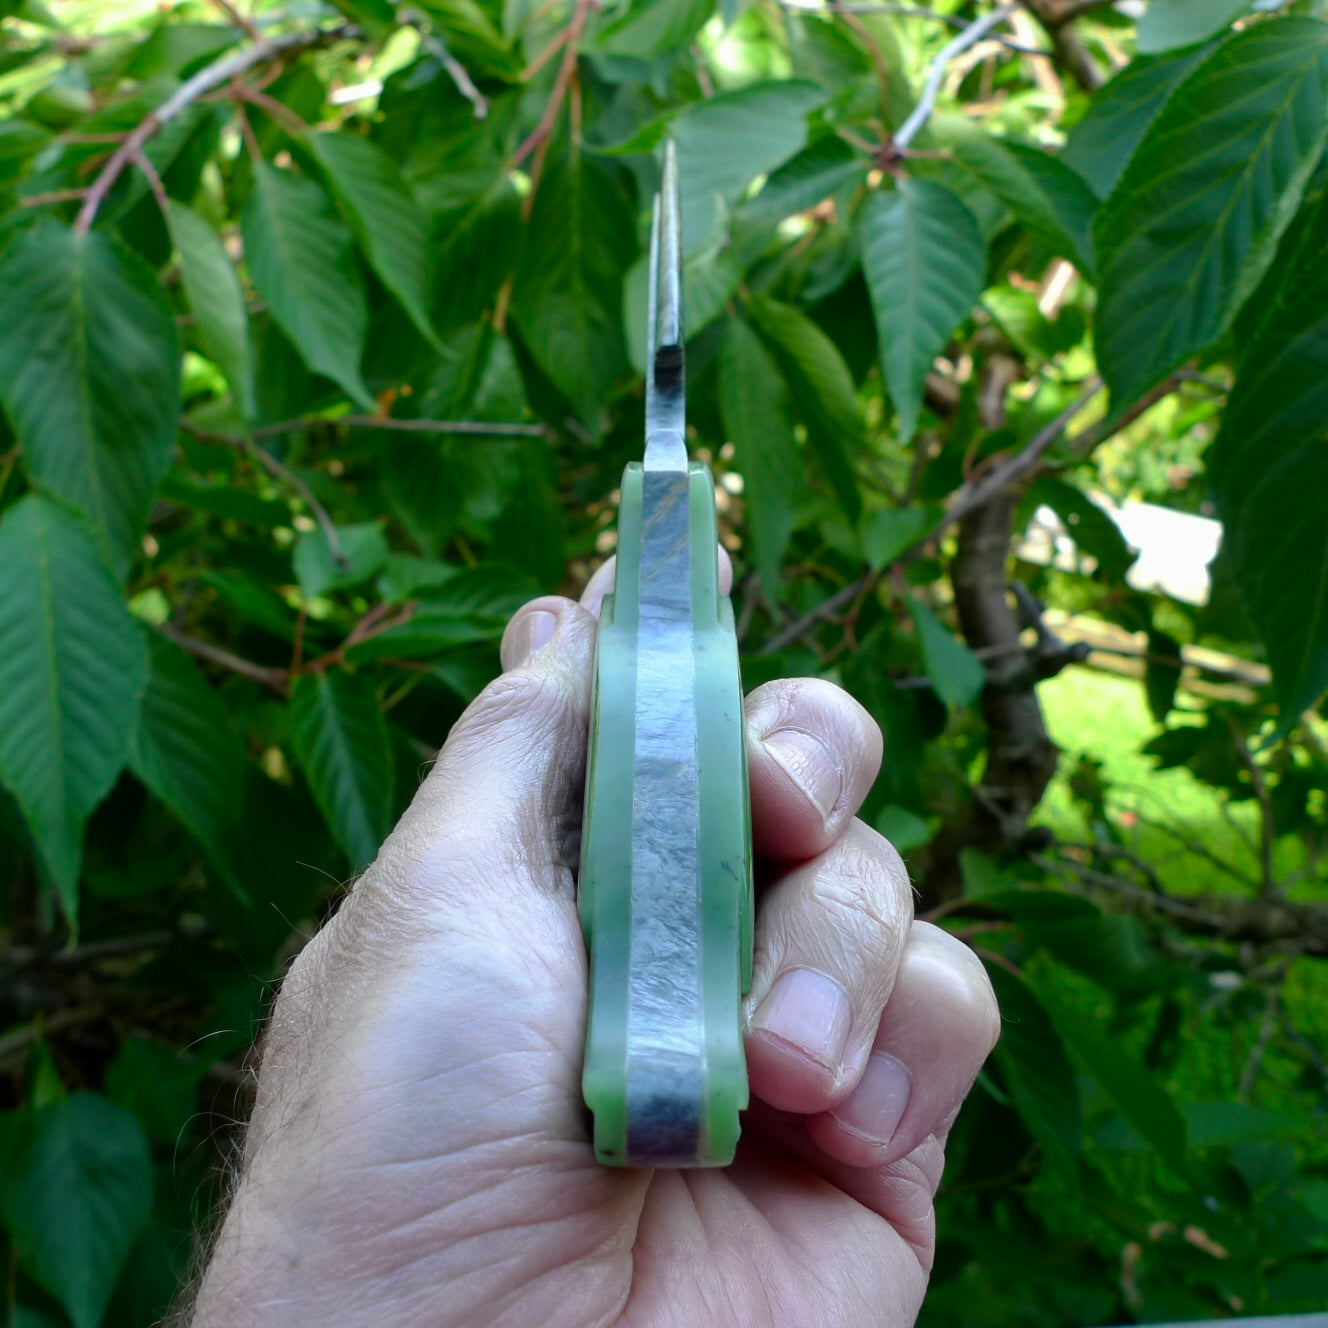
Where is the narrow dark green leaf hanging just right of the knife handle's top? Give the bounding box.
[720,319,805,604]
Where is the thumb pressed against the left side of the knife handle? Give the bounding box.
[373,595,595,907]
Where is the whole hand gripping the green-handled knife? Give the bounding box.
[194,578,999,1328]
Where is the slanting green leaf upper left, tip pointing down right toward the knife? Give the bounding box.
[305,133,442,351]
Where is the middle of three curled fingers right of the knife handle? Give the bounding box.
[745,821,912,1114]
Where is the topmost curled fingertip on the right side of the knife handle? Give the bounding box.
[746,677,882,862]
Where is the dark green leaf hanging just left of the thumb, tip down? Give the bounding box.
[291,669,394,870]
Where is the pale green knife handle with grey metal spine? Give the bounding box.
[579,462,753,1167]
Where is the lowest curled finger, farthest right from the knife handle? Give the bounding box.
[807,922,1000,1167]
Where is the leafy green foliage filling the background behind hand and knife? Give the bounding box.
[0,0,1328,1328]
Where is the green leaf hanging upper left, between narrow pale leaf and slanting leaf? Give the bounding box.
[240,161,376,410]
